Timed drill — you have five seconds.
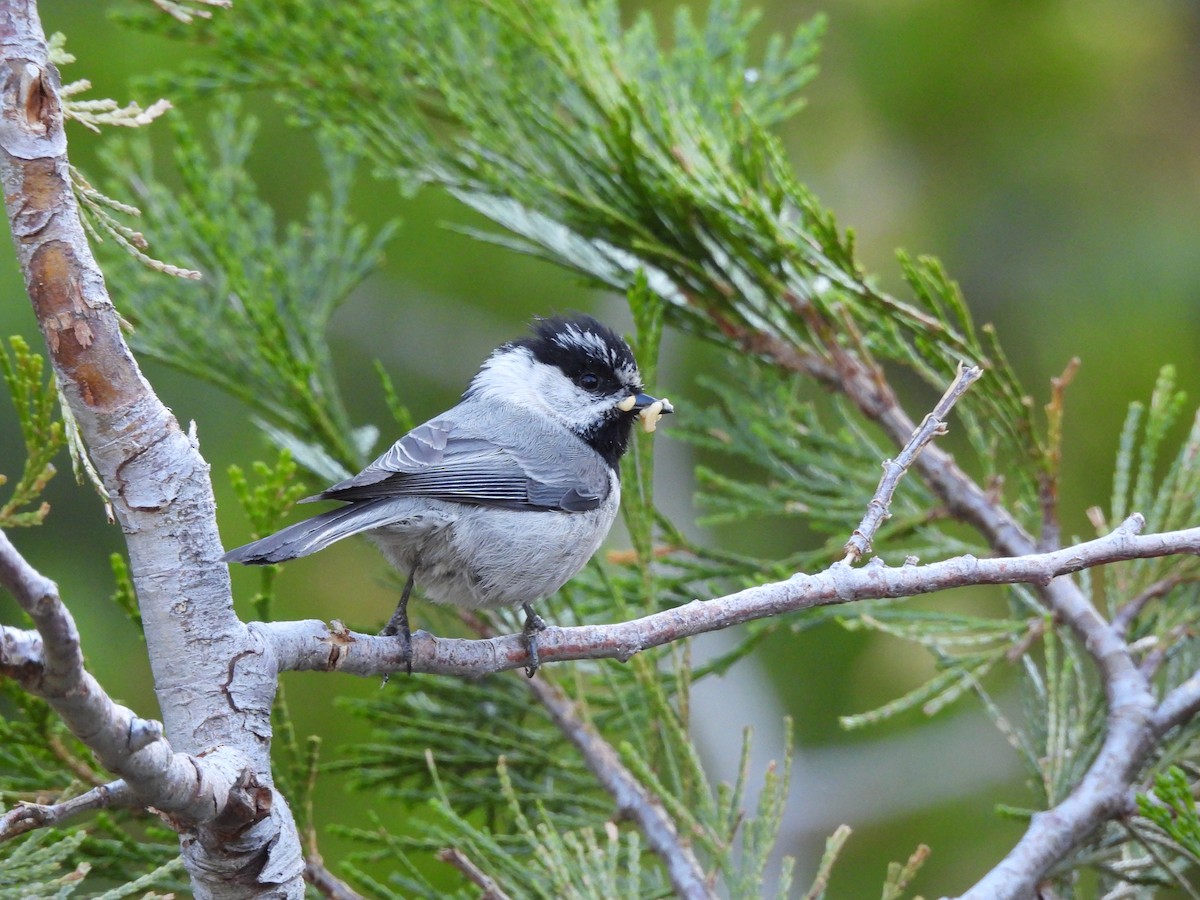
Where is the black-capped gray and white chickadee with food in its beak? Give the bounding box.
[222,316,673,677]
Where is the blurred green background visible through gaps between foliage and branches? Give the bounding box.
[0,0,1200,898]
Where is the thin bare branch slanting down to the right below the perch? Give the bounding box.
[529,679,716,900]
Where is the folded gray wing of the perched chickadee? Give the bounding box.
[311,418,611,512]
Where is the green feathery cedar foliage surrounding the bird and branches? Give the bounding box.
[7,0,1200,898]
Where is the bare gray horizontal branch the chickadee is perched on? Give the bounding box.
[260,515,1200,677]
